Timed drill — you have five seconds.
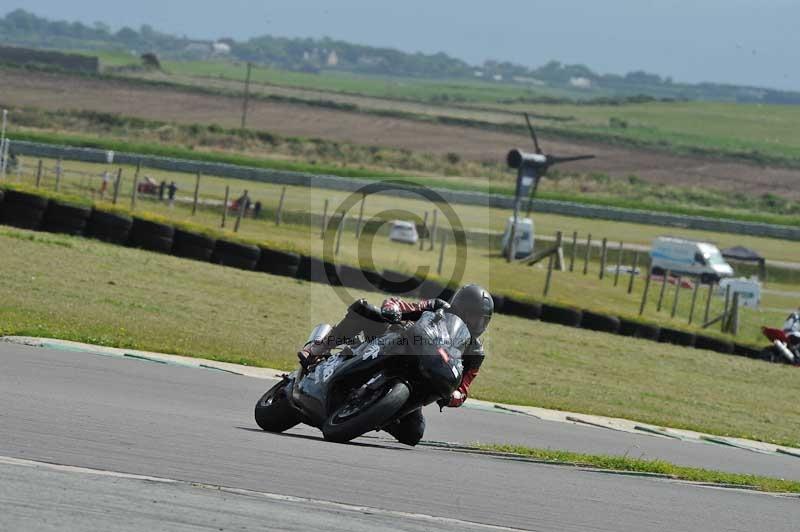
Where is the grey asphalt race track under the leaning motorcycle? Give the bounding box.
[0,344,800,531]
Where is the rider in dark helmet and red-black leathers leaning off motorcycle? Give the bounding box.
[297,284,494,445]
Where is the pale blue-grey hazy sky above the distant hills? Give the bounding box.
[6,0,800,90]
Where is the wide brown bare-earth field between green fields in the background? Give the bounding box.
[0,70,800,199]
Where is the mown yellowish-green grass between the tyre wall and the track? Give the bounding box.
[0,227,800,444]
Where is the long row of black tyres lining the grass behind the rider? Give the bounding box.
[0,185,783,362]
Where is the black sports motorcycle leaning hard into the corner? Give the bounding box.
[255,310,470,442]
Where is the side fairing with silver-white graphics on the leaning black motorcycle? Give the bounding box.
[291,332,408,427]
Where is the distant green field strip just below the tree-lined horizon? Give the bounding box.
[137,62,800,165]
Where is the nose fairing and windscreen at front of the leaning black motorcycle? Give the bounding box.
[411,312,471,398]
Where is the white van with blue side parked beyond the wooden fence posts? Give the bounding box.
[650,236,733,283]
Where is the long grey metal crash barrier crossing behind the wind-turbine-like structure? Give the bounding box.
[11,141,800,240]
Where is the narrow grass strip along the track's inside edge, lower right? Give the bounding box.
[477,445,800,493]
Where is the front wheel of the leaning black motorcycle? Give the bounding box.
[322,380,411,443]
